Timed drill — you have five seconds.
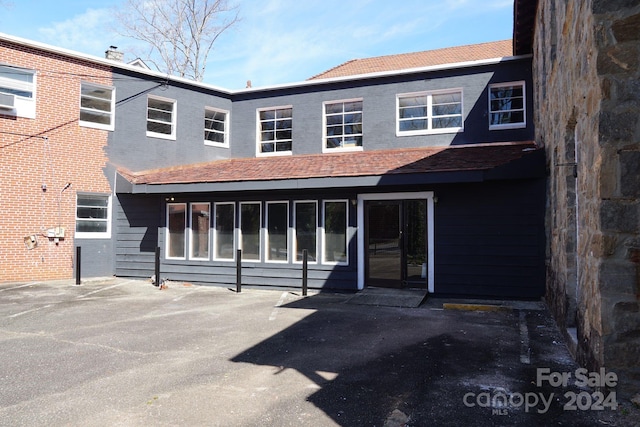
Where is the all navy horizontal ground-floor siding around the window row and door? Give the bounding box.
[116,179,544,298]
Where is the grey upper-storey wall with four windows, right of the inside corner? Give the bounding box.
[231,59,533,157]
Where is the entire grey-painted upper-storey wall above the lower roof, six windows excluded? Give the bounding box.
[107,58,533,171]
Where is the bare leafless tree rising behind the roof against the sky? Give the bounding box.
[115,0,240,81]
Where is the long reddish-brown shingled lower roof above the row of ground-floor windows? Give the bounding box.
[120,141,536,185]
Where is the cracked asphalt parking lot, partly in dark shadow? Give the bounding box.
[0,278,640,427]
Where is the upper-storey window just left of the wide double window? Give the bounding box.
[322,99,362,152]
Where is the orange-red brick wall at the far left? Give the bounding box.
[0,41,112,282]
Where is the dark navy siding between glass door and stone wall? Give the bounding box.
[434,179,544,298]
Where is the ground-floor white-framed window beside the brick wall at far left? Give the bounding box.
[75,193,111,239]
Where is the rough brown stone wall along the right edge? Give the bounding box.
[533,0,640,393]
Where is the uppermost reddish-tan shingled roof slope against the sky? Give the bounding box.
[308,40,513,80]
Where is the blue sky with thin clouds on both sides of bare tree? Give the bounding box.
[0,0,513,89]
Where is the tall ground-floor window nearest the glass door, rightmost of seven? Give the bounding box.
[322,200,349,265]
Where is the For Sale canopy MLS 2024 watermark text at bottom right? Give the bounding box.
[462,368,618,415]
